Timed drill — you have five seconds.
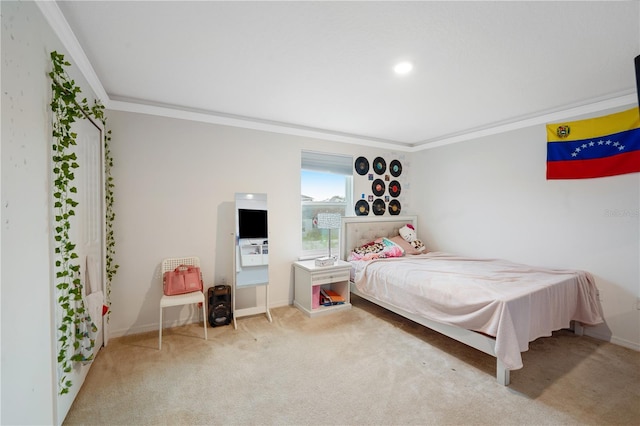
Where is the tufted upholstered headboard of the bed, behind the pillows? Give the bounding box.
[340,216,418,260]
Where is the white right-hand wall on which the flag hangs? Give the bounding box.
[412,120,640,350]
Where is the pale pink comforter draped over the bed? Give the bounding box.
[352,252,603,370]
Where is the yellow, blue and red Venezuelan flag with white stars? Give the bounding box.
[547,108,640,179]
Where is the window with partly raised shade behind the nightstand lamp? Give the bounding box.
[300,151,353,258]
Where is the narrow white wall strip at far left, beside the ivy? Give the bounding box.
[0,1,99,424]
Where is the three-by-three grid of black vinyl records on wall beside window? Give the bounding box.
[354,156,402,216]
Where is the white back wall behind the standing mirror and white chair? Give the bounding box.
[107,111,408,336]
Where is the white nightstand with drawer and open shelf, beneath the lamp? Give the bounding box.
[293,260,351,317]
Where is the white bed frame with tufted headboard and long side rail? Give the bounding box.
[340,216,509,386]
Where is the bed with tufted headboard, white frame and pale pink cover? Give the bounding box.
[341,216,603,386]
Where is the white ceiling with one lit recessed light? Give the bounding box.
[48,1,640,148]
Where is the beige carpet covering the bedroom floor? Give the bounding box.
[65,297,640,425]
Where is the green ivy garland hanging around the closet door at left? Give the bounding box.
[49,51,118,394]
